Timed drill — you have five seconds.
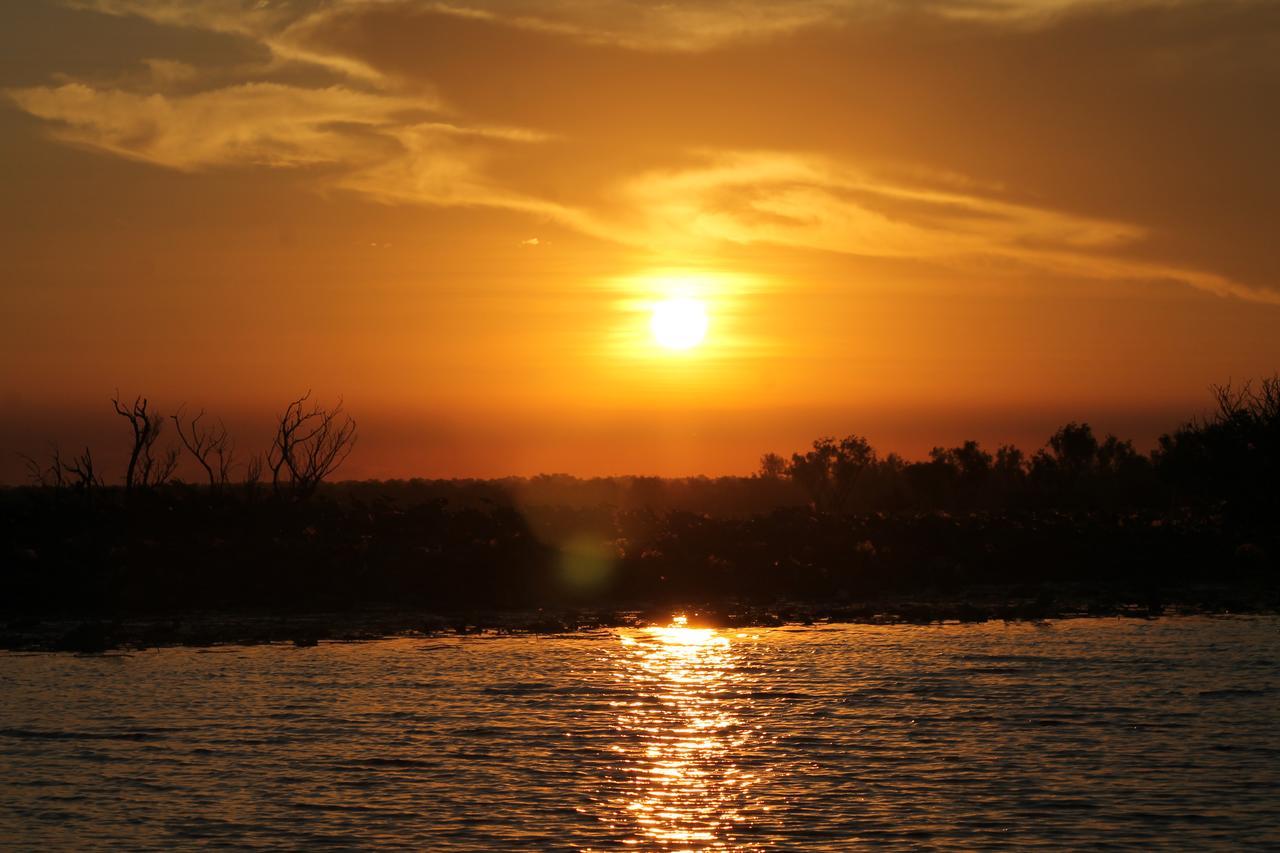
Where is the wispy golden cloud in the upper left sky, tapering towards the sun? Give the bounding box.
[9,75,575,222]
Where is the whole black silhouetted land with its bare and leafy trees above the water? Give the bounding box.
[0,378,1280,645]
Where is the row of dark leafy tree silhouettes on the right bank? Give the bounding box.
[758,374,1280,519]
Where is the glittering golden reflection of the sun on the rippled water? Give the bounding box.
[605,616,759,850]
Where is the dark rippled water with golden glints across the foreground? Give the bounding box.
[0,617,1280,850]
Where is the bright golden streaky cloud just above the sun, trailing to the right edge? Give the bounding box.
[576,151,1280,304]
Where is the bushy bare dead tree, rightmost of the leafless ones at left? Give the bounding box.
[266,391,356,498]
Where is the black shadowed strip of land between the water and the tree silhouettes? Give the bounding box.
[0,468,1280,652]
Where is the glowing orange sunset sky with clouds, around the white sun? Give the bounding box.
[0,0,1280,482]
